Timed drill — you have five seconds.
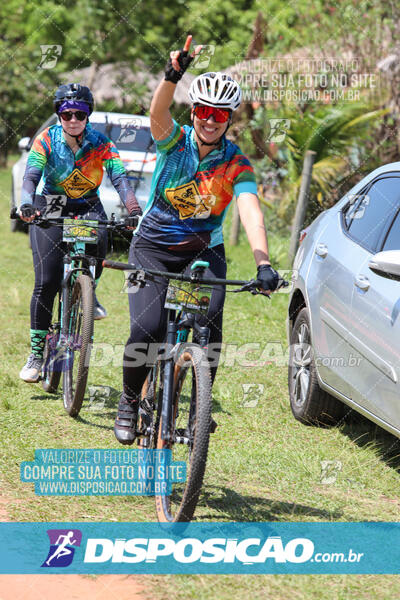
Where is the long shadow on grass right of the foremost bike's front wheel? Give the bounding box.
[198,486,343,521]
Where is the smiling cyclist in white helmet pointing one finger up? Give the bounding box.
[114,36,279,444]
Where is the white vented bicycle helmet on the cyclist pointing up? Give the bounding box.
[189,73,242,110]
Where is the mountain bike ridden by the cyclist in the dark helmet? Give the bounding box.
[10,211,131,417]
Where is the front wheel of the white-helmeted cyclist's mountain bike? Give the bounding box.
[156,344,211,522]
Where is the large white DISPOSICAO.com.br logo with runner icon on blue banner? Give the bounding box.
[35,523,365,573]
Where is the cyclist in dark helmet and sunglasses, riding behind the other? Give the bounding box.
[19,83,141,383]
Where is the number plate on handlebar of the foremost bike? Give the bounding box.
[164,279,212,314]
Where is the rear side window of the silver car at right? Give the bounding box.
[344,177,400,252]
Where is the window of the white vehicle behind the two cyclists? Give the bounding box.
[90,118,155,152]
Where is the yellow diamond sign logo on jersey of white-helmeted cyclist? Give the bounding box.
[165,181,216,219]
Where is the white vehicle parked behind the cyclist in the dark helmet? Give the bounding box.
[11,111,156,231]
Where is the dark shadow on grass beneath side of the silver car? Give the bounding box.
[340,411,400,473]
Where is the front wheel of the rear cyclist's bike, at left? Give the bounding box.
[63,275,94,417]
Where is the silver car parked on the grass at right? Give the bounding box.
[287,162,400,437]
